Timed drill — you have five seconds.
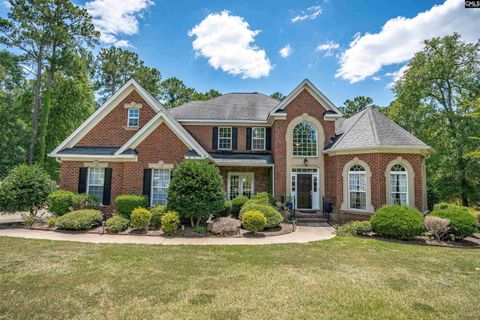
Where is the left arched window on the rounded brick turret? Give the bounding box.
[348,164,367,210]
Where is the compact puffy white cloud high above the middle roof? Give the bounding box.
[188,10,272,79]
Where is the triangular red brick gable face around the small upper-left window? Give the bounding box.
[76,91,156,147]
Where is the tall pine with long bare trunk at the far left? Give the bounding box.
[0,0,98,163]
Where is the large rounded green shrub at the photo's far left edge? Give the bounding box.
[0,164,55,216]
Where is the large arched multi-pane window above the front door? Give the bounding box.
[293,121,317,157]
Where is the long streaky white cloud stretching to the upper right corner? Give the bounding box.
[335,0,480,83]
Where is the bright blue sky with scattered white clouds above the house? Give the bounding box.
[0,0,480,106]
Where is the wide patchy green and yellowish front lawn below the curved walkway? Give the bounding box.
[0,238,480,320]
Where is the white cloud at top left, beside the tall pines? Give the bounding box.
[85,0,154,47]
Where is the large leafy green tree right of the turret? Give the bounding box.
[389,34,480,205]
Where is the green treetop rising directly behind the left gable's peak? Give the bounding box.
[95,47,161,102]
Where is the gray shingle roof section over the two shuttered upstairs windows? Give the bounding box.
[169,93,279,121]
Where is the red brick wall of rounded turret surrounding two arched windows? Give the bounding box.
[325,153,423,210]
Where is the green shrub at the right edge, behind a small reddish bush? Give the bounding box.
[430,206,477,239]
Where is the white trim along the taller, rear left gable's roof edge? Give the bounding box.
[49,79,162,157]
